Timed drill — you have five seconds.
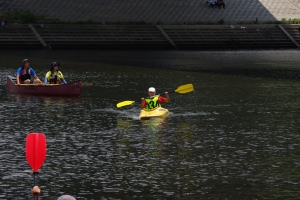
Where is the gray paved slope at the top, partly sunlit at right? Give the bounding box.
[0,0,300,24]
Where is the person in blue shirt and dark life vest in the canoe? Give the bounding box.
[17,59,43,85]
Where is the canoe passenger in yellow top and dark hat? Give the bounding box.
[44,62,67,84]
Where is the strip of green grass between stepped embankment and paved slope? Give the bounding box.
[0,10,300,25]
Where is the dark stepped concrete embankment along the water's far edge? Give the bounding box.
[0,24,300,50]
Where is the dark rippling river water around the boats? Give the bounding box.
[0,50,300,200]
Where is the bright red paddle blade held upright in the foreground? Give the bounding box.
[26,133,46,172]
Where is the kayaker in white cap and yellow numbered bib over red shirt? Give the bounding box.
[141,87,170,110]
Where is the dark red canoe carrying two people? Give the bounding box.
[6,76,82,96]
